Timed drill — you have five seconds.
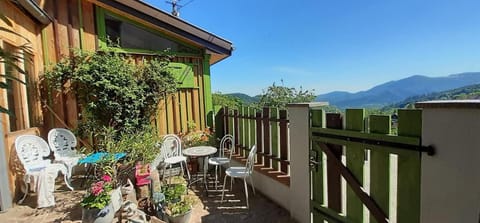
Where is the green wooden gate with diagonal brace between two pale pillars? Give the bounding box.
[310,109,433,223]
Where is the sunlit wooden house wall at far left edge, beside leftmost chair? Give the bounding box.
[0,1,43,197]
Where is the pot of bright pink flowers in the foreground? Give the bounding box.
[80,175,117,223]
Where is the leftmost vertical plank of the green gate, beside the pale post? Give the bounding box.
[310,109,326,223]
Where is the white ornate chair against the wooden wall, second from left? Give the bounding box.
[48,128,82,186]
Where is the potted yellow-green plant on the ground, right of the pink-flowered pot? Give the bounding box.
[162,184,193,223]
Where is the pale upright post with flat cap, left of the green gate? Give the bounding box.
[287,102,328,223]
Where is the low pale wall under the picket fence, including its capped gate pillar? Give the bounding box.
[232,102,328,223]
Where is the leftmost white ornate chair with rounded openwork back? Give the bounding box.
[15,135,73,204]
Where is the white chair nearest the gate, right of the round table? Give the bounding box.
[222,145,257,208]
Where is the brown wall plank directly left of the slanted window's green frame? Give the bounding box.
[82,0,97,51]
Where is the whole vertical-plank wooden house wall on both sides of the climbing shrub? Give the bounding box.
[0,0,209,199]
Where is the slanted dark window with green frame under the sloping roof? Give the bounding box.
[105,14,200,54]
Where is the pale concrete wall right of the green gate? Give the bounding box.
[417,101,480,223]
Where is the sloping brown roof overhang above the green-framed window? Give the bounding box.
[90,0,233,64]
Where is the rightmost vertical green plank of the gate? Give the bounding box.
[397,109,422,223]
